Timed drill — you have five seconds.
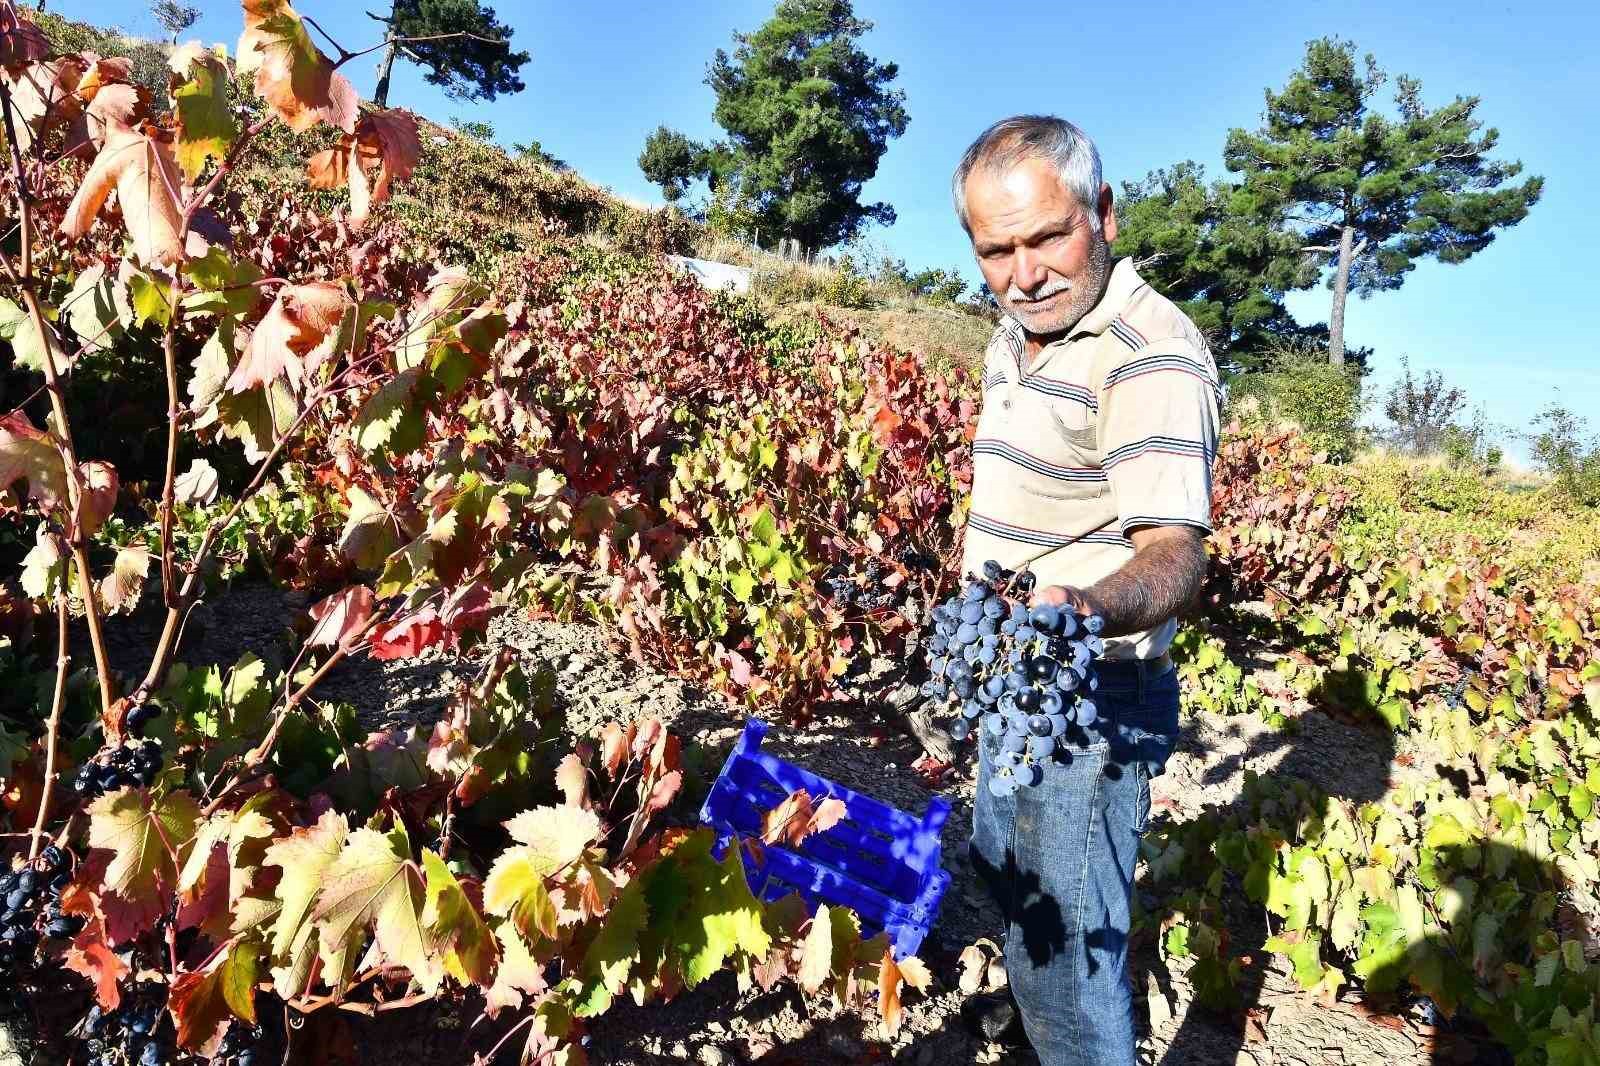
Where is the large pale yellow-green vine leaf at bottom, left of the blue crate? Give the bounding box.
[315,826,442,991]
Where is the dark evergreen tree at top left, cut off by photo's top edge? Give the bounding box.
[373,0,528,107]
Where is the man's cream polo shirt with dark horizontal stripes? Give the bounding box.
[962,259,1219,659]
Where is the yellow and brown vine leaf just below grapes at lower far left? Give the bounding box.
[88,789,200,944]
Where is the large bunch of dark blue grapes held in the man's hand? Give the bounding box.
[923,560,1104,795]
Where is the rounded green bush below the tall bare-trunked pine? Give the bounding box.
[1227,351,1365,461]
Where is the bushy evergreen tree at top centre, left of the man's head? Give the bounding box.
[640,0,909,248]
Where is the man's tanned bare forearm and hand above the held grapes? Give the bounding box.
[1034,525,1205,637]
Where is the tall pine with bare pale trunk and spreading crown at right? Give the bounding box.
[1224,38,1544,363]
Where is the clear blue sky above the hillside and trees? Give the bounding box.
[50,0,1600,456]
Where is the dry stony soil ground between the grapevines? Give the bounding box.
[12,584,1498,1066]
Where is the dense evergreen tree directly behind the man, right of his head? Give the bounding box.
[1114,160,1318,356]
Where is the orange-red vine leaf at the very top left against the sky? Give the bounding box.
[235,0,360,133]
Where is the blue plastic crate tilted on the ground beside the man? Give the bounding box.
[701,719,950,959]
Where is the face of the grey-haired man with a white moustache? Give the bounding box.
[966,158,1117,336]
